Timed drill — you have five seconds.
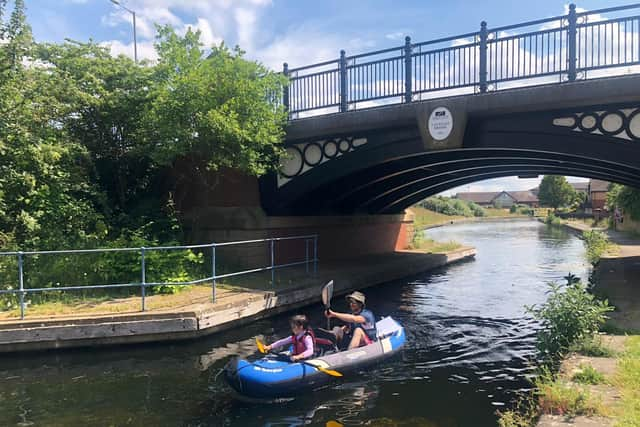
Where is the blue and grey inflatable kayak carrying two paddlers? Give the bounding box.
[225,317,405,399]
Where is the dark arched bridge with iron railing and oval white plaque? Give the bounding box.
[261,4,640,215]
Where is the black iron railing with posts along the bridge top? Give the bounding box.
[283,3,640,119]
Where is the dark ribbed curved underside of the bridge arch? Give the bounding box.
[287,149,640,215]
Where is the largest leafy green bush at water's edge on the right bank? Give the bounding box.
[527,282,613,361]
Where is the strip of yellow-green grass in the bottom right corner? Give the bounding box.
[614,336,640,427]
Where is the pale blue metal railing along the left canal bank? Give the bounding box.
[0,234,318,319]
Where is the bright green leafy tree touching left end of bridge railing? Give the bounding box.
[146,26,286,175]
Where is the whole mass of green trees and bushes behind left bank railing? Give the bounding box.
[0,0,286,309]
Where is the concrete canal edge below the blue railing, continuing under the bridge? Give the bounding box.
[0,247,476,353]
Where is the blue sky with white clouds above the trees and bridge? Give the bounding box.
[17,0,629,194]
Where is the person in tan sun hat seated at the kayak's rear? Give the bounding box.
[325,291,376,350]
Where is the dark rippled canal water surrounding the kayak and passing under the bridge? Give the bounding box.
[0,221,587,427]
